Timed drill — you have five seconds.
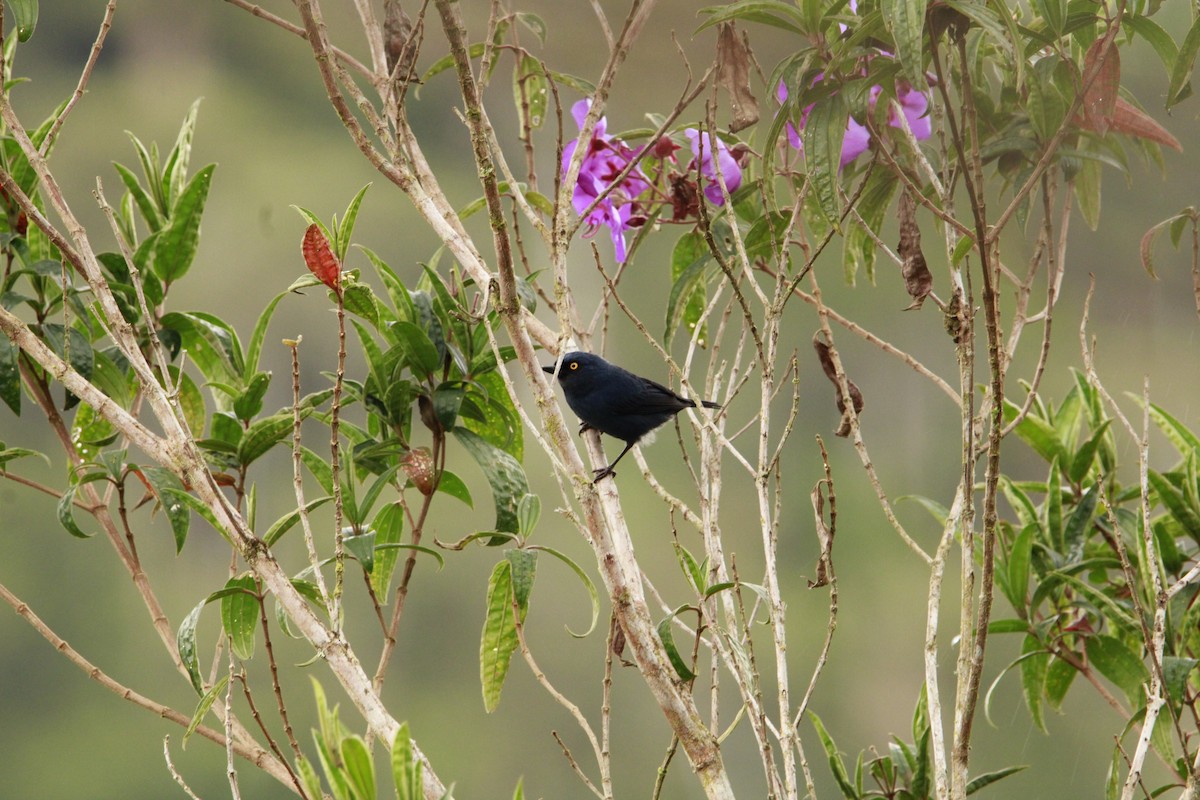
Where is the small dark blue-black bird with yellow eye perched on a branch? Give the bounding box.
[541,351,721,483]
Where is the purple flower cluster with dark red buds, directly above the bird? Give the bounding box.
[562,100,742,263]
